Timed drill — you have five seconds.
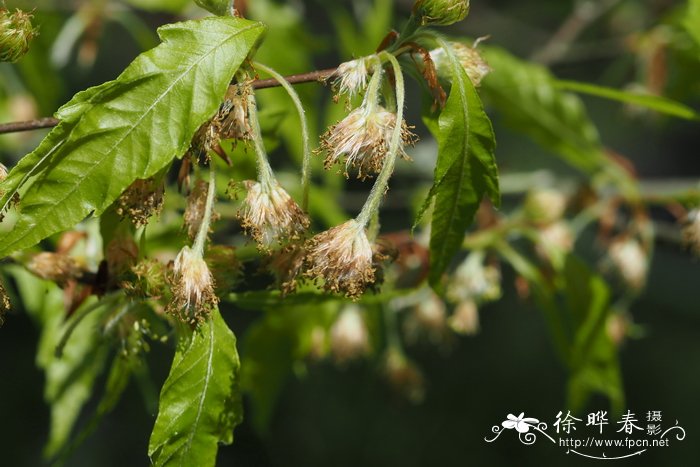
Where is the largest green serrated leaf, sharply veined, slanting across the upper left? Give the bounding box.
[0,17,264,257]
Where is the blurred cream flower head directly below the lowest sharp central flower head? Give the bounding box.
[331,305,370,363]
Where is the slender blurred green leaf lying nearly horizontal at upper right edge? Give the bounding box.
[555,80,700,120]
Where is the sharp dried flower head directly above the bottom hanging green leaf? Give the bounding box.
[167,246,219,325]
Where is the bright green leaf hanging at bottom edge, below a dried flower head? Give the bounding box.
[148,309,243,467]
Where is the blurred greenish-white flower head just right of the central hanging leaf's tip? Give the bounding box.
[447,251,501,303]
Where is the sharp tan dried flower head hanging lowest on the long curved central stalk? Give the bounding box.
[304,219,374,298]
